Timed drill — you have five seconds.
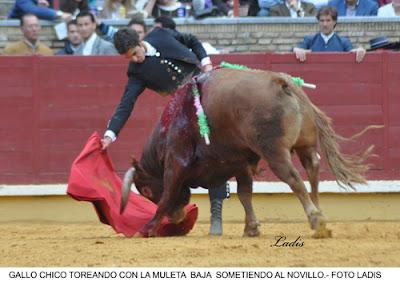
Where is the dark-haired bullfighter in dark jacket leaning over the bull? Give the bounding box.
[102,27,227,235]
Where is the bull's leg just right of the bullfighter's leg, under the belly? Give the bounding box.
[236,171,260,237]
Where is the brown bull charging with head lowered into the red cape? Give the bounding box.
[121,69,372,238]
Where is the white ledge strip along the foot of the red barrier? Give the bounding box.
[0,180,400,196]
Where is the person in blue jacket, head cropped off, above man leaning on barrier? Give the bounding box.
[328,0,378,17]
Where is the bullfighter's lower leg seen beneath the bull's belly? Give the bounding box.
[208,183,229,235]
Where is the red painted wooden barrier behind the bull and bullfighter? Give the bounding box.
[0,52,400,184]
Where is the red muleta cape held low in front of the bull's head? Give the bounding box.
[67,132,198,237]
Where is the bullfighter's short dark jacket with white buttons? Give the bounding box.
[107,28,207,135]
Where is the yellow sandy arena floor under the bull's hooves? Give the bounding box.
[0,221,400,267]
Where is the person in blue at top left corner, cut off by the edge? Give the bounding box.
[8,0,72,21]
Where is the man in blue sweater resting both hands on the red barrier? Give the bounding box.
[293,6,365,62]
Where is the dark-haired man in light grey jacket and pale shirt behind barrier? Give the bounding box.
[76,12,117,56]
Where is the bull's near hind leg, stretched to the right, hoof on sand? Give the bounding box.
[266,149,331,238]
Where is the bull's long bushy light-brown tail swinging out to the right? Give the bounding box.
[311,103,382,190]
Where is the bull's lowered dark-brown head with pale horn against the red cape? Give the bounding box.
[120,158,163,214]
